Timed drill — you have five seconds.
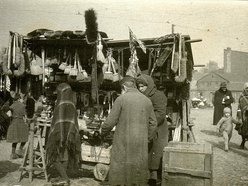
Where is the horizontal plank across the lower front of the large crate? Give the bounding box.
[165,167,212,178]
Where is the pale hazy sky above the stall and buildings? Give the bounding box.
[0,0,248,67]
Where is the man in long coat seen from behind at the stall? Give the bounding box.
[102,77,157,185]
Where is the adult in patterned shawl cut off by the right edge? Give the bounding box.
[237,82,248,149]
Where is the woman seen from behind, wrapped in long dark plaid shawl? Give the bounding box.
[46,83,81,185]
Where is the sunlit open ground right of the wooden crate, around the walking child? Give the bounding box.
[191,105,248,186]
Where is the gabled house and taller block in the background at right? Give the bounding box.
[191,47,248,103]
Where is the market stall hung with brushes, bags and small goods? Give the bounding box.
[0,10,200,179]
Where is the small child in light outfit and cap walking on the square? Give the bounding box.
[217,107,240,152]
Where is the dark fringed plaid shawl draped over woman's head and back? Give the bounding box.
[46,83,80,165]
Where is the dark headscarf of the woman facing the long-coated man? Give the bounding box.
[136,74,157,97]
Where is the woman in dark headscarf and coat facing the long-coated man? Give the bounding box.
[136,74,168,185]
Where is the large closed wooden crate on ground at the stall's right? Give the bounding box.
[162,142,213,186]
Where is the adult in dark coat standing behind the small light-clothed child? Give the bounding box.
[213,82,234,125]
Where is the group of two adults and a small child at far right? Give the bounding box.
[213,82,248,152]
